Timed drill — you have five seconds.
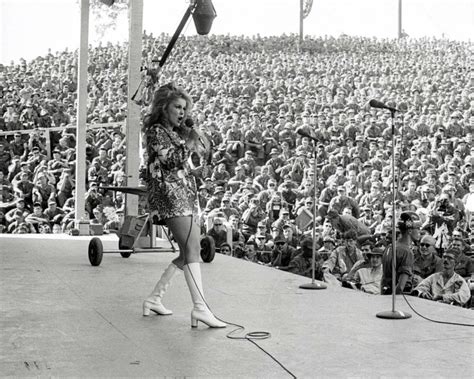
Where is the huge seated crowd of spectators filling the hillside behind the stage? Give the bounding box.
[0,33,474,306]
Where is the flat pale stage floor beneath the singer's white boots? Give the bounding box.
[0,235,474,378]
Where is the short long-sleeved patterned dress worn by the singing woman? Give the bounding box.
[144,125,196,224]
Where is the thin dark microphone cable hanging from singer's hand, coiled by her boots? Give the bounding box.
[184,189,296,379]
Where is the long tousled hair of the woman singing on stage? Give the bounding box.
[143,83,193,132]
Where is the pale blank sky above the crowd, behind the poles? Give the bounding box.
[0,0,474,64]
